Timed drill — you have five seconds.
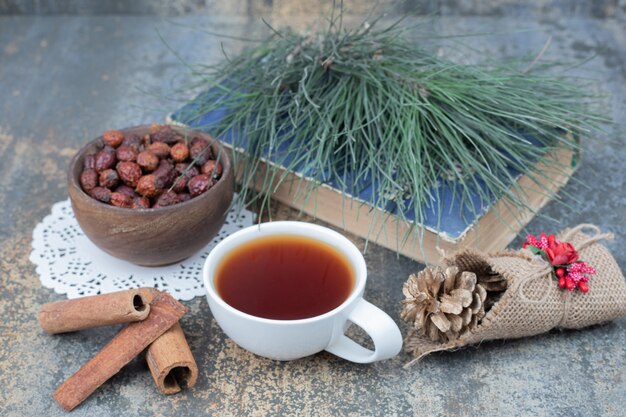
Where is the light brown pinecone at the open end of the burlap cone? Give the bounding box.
[400,266,487,343]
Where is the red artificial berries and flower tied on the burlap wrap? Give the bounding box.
[522,233,596,292]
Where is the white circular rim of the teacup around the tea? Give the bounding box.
[202,220,367,326]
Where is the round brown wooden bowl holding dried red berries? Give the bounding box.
[67,125,233,266]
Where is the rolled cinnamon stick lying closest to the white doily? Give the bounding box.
[39,289,150,334]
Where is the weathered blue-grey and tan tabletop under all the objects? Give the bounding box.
[0,16,626,417]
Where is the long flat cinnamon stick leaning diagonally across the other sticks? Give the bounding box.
[53,292,186,411]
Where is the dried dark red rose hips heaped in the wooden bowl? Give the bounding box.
[80,125,222,209]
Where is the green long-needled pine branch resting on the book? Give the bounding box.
[174,8,606,245]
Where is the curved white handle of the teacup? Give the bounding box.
[326,298,402,363]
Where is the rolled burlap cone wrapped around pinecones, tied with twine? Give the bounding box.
[405,225,626,360]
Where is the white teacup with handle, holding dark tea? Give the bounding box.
[203,221,402,363]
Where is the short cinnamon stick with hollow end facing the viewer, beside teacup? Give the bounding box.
[146,323,198,394]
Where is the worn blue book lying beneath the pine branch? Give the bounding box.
[168,91,577,264]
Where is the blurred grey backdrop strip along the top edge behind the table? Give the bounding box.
[0,0,626,18]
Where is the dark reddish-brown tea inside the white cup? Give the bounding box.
[215,235,354,320]
